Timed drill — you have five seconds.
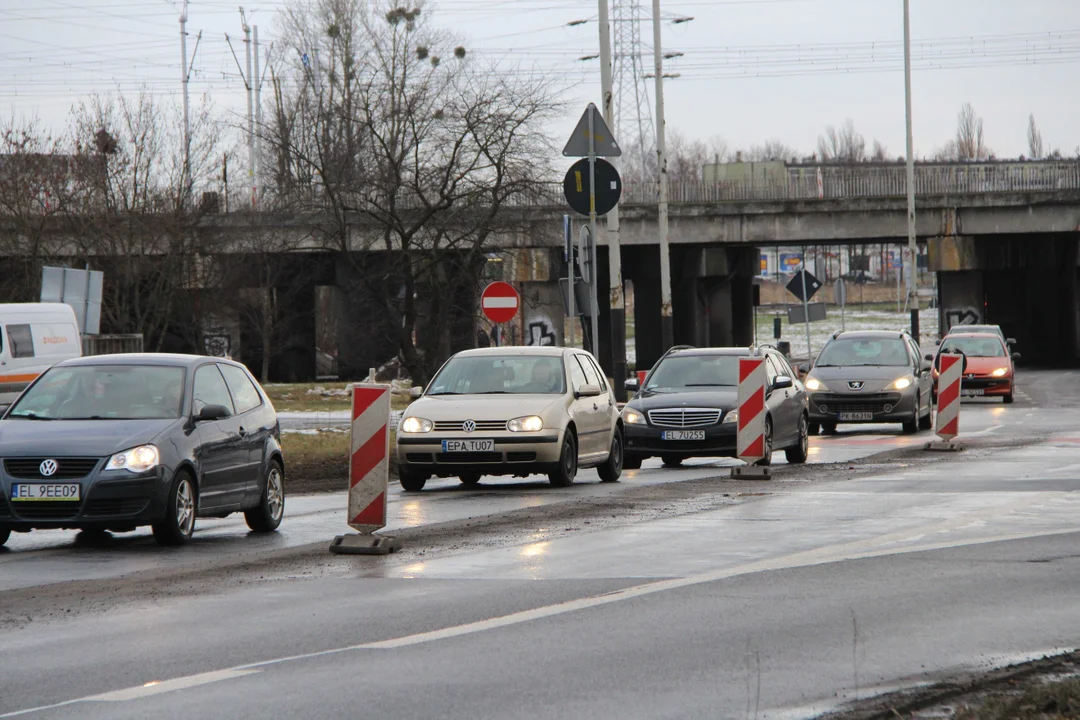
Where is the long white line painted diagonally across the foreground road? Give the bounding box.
[0,518,1076,719]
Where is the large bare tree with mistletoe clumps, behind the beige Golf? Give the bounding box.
[264,0,557,382]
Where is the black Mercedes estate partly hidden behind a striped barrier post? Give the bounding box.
[622,347,809,470]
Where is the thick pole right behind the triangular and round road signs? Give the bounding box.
[593,0,626,402]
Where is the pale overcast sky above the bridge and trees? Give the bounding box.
[0,0,1080,157]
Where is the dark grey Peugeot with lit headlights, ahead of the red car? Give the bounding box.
[806,330,933,434]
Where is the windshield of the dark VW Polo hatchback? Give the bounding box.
[8,365,184,420]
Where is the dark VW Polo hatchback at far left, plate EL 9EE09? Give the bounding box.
[0,353,285,545]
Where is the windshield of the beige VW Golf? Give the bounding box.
[427,355,566,395]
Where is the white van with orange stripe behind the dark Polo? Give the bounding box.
[0,302,82,409]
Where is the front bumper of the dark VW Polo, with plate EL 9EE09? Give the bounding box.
[0,460,171,532]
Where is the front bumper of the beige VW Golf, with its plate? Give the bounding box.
[396,431,563,477]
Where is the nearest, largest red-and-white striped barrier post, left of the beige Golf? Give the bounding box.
[330,383,401,555]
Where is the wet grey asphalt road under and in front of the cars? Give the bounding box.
[0,372,1080,718]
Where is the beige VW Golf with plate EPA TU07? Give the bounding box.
[397,348,622,491]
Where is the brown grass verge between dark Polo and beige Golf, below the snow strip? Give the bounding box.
[281,431,396,492]
